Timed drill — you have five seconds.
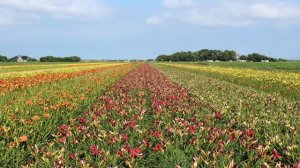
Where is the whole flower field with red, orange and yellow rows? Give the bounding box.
[0,63,300,167]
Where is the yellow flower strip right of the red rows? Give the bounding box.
[163,63,300,100]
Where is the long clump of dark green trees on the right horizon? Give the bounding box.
[156,49,282,62]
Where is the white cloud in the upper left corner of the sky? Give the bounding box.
[0,0,112,24]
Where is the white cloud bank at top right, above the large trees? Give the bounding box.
[146,0,300,26]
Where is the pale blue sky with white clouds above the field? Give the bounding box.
[0,0,300,59]
